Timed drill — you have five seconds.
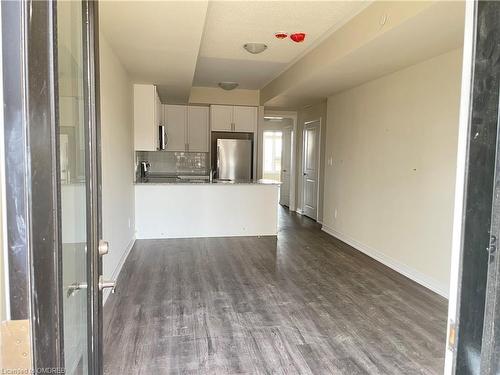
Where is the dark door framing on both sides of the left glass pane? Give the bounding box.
[1,0,102,374]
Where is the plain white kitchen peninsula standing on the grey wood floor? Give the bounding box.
[135,180,279,239]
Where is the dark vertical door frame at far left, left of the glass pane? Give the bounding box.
[1,1,63,369]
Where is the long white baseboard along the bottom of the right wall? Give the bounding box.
[321,225,449,299]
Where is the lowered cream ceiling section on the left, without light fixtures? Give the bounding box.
[99,0,208,101]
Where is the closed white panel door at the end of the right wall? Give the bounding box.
[302,120,320,220]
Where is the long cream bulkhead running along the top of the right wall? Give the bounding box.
[265,1,465,107]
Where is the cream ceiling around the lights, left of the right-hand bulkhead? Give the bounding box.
[99,0,368,102]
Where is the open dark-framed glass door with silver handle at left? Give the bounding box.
[1,0,104,374]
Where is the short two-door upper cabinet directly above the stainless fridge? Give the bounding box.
[210,105,257,133]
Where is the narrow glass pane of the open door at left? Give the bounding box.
[57,1,89,374]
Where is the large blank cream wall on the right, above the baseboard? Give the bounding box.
[323,50,462,296]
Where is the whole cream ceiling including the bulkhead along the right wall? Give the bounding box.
[99,0,464,107]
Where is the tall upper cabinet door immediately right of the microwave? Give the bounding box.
[165,104,187,151]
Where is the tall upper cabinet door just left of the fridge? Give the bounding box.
[187,106,210,152]
